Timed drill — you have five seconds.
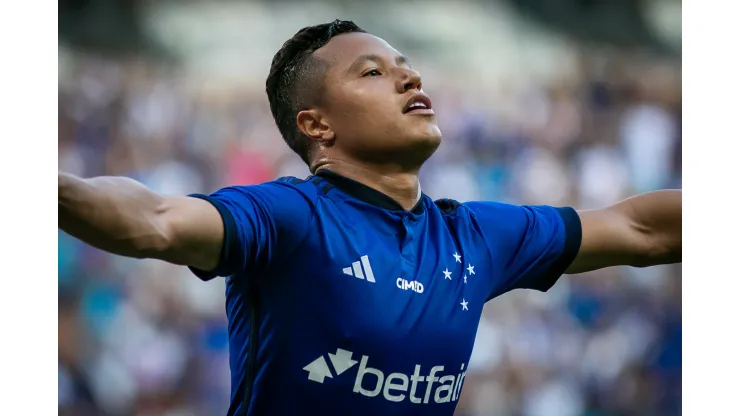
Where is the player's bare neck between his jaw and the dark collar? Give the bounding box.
[315,161,421,211]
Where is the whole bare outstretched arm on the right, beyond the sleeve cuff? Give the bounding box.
[566,190,681,273]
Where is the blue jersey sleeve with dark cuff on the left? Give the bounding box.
[190,182,313,280]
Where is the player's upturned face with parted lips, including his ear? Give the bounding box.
[298,33,442,167]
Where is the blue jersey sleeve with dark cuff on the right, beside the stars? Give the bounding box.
[465,202,581,300]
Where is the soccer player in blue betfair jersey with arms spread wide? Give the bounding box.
[58,20,681,416]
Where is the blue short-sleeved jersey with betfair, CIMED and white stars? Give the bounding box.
[188,171,581,416]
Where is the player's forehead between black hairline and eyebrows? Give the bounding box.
[314,33,401,69]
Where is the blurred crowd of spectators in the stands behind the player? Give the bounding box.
[59,39,681,416]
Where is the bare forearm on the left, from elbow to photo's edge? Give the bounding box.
[58,173,167,258]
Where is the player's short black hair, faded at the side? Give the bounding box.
[265,19,366,165]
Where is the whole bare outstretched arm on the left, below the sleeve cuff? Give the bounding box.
[58,173,224,271]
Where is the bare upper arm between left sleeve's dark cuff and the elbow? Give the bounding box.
[155,196,224,271]
